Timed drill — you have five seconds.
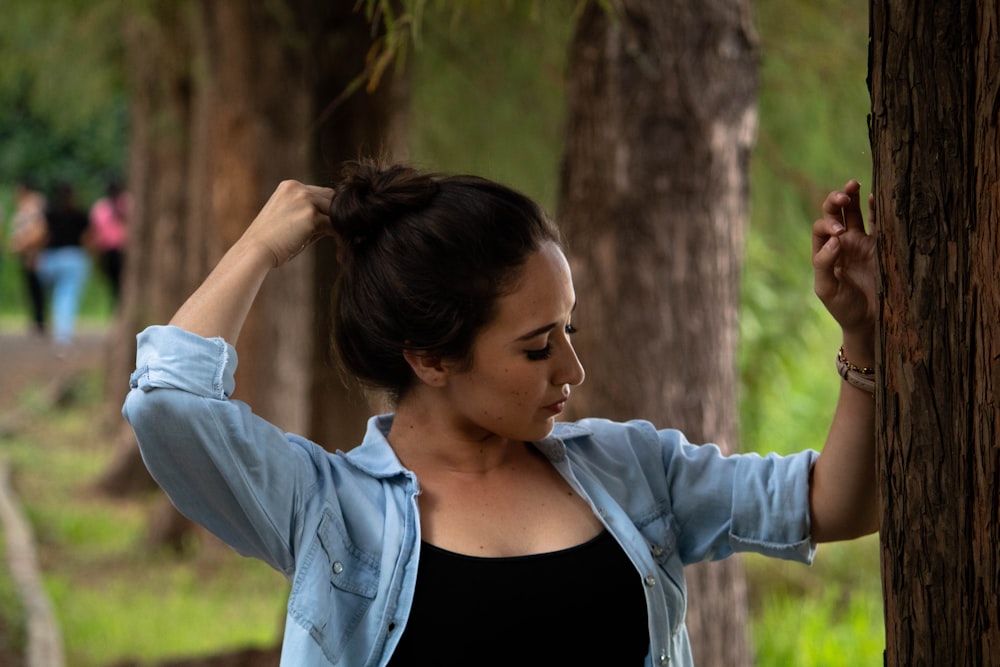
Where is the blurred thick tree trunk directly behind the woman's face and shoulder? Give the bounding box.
[559,0,758,666]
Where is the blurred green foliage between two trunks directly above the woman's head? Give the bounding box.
[410,2,578,211]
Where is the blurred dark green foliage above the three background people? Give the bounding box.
[0,0,128,201]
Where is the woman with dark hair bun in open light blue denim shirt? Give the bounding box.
[124,164,875,666]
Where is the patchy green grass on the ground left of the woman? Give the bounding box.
[0,368,288,667]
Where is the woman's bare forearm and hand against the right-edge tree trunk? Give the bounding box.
[810,181,878,542]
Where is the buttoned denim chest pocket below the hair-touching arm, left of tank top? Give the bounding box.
[288,510,379,663]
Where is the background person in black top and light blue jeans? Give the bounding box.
[37,183,91,350]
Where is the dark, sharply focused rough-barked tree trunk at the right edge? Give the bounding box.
[869,0,1000,666]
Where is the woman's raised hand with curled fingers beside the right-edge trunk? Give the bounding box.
[812,180,877,337]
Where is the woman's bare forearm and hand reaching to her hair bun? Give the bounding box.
[170,181,333,345]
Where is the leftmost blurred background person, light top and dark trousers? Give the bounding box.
[10,179,48,335]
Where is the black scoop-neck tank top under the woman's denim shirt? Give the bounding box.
[389,531,649,667]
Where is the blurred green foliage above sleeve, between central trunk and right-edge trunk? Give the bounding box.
[740,0,871,451]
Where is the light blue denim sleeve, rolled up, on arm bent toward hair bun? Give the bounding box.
[122,326,321,574]
